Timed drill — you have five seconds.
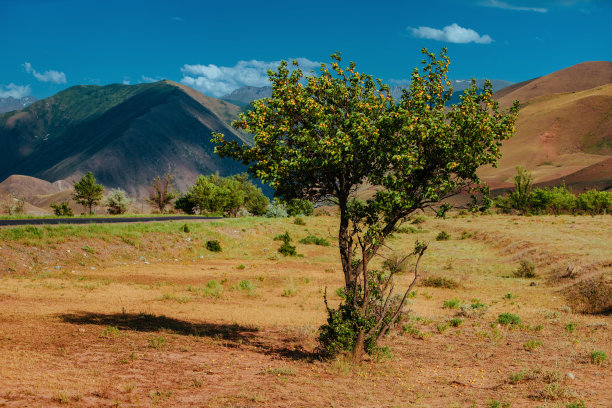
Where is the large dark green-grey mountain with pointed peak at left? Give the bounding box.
[0,80,252,197]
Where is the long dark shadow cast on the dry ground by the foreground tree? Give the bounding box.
[58,312,317,361]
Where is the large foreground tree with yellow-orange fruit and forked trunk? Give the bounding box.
[213,49,518,361]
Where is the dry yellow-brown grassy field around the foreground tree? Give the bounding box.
[0,212,612,407]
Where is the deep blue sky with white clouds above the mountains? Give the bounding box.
[0,0,612,98]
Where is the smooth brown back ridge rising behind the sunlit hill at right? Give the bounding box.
[495,61,612,106]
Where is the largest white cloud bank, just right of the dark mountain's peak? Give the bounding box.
[181,58,321,97]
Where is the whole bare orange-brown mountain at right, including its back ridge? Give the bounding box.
[481,62,612,192]
